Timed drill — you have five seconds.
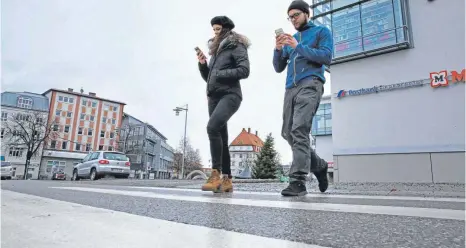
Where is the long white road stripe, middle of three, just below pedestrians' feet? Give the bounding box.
[51,187,465,220]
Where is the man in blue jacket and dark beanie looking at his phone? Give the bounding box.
[273,0,333,196]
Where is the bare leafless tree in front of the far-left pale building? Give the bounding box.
[2,111,58,179]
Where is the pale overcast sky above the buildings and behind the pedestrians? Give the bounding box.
[1,0,330,167]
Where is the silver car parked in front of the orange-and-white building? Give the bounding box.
[71,151,131,181]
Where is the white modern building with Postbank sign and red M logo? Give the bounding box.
[312,0,466,183]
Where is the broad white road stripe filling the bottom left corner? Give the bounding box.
[2,190,325,248]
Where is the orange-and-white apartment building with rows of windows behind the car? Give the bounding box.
[41,88,126,175]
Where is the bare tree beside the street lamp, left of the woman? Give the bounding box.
[171,137,202,178]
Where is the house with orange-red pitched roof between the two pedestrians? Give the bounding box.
[229,128,264,178]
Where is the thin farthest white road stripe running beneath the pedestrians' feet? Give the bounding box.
[124,186,465,202]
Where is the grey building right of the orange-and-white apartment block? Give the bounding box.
[119,113,174,179]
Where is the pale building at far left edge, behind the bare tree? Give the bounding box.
[1,92,49,179]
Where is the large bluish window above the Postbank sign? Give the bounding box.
[312,0,410,63]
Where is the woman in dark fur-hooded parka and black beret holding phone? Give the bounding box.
[197,16,250,192]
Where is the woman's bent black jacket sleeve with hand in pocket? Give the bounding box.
[215,44,249,80]
